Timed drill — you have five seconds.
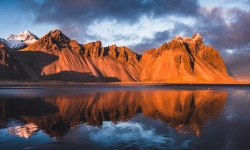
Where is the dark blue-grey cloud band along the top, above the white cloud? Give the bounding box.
[25,0,199,24]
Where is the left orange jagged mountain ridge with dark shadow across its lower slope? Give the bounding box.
[20,30,139,82]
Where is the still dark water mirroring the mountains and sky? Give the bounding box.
[0,85,250,150]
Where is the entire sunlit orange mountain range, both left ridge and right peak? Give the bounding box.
[18,30,235,83]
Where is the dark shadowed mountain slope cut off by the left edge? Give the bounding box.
[0,39,28,80]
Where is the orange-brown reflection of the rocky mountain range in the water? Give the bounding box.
[0,90,227,137]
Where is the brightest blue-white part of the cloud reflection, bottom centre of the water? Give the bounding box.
[89,121,170,148]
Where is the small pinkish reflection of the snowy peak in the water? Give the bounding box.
[7,123,37,139]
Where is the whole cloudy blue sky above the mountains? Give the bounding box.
[0,0,250,82]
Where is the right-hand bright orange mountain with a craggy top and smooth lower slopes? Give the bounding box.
[140,34,235,83]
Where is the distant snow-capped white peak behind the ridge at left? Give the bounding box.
[7,30,39,45]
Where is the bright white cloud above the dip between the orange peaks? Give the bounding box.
[85,16,196,46]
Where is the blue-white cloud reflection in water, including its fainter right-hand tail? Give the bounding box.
[87,121,194,149]
